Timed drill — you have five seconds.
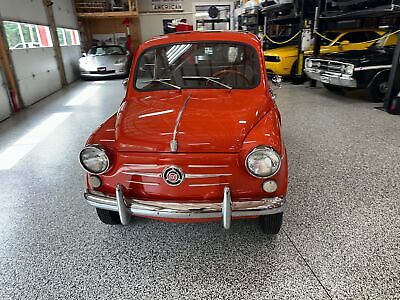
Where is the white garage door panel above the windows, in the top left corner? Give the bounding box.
[0,0,48,25]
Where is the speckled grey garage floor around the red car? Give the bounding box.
[0,80,400,299]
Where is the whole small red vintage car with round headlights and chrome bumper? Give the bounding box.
[80,31,288,233]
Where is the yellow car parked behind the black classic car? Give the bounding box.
[264,29,386,76]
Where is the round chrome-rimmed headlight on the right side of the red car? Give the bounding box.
[246,146,281,178]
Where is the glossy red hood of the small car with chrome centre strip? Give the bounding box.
[116,90,272,153]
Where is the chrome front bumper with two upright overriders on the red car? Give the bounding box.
[84,185,285,229]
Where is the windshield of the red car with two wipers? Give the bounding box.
[135,42,261,91]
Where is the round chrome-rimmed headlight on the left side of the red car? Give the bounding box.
[79,145,110,174]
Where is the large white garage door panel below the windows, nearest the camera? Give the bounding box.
[11,48,61,106]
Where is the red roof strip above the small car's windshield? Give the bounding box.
[141,30,262,50]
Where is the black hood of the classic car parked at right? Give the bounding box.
[320,47,394,65]
